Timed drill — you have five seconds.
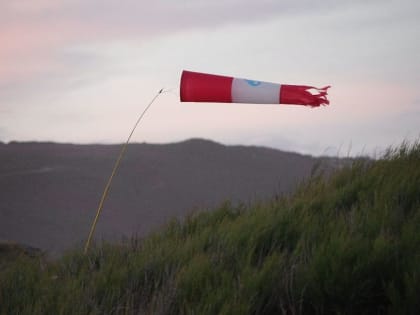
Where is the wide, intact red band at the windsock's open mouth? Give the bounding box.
[180,70,233,103]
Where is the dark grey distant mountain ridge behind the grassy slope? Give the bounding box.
[0,139,336,252]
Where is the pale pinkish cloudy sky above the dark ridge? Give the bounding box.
[0,0,420,156]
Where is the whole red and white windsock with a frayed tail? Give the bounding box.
[181,70,329,107]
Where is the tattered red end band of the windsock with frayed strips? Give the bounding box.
[280,84,330,107]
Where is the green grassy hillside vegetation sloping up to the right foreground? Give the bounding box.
[0,143,420,314]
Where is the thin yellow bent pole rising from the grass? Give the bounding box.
[84,89,163,255]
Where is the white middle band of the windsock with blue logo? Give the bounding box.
[232,78,281,104]
